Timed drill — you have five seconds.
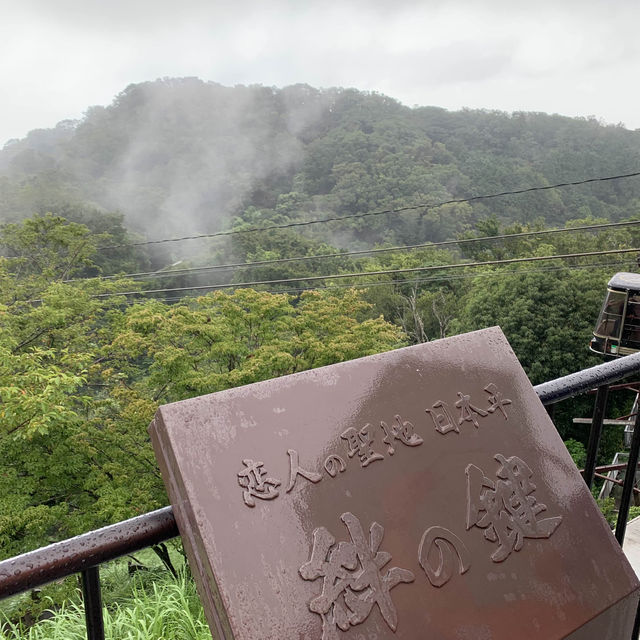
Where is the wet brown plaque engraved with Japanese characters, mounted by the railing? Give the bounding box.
[150,328,639,640]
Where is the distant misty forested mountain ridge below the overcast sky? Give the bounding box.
[0,78,640,257]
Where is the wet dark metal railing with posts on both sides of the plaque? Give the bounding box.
[0,353,640,640]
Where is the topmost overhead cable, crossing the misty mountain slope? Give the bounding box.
[98,171,640,250]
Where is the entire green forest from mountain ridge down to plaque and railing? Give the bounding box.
[0,78,640,632]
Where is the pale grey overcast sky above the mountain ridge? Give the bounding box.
[0,0,640,146]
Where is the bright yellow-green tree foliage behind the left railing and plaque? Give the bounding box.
[0,217,404,557]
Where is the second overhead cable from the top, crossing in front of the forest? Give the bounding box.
[81,220,640,282]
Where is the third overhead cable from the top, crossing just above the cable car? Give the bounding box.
[92,247,640,298]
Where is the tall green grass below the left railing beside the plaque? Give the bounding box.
[0,573,211,640]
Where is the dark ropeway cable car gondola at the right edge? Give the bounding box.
[589,272,640,357]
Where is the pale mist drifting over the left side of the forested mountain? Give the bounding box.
[0,78,335,239]
